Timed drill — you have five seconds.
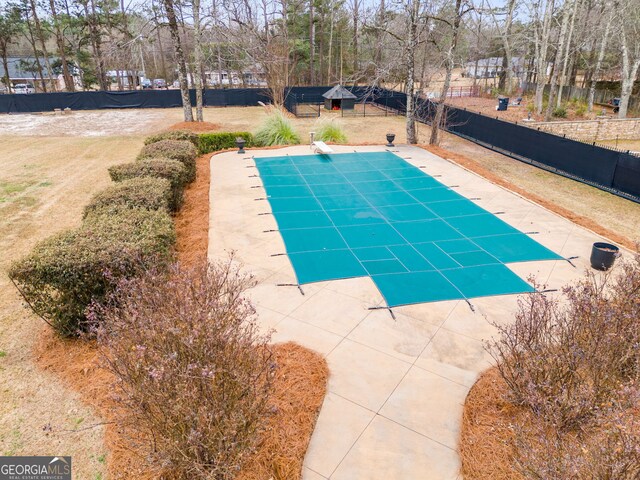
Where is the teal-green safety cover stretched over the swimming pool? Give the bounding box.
[255,152,562,306]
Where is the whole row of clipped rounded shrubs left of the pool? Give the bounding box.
[9,132,205,336]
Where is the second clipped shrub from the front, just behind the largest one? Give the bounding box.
[84,177,172,217]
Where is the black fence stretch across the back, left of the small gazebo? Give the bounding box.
[0,88,271,113]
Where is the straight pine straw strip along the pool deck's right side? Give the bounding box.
[418,145,636,251]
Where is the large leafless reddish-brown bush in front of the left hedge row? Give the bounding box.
[92,260,274,479]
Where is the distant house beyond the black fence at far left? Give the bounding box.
[0,56,82,93]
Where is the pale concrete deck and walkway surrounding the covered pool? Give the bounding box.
[209,146,602,480]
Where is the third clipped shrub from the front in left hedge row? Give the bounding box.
[109,159,187,211]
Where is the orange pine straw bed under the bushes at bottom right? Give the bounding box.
[458,367,640,480]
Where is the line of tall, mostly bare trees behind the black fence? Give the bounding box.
[0,0,640,136]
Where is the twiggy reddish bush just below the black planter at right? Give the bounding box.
[489,256,640,429]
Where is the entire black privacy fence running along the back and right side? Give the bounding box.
[0,86,640,202]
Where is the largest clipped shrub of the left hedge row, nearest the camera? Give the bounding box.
[9,207,176,336]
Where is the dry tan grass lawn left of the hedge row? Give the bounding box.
[0,136,142,480]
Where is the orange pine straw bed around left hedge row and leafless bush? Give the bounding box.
[34,148,329,480]
